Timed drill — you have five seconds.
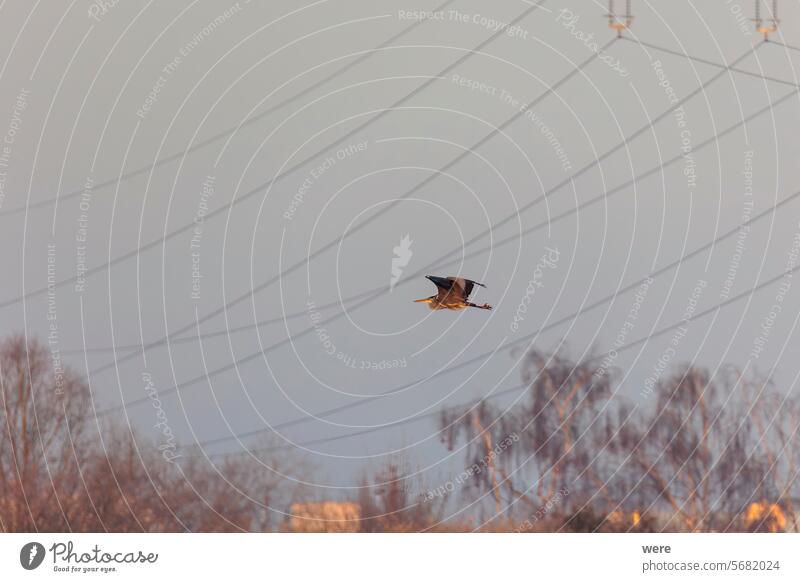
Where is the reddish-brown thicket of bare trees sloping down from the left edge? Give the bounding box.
[0,336,303,532]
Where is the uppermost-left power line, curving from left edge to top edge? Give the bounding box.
[0,0,455,217]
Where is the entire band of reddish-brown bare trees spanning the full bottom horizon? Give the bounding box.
[0,336,800,532]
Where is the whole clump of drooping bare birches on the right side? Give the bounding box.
[440,351,800,531]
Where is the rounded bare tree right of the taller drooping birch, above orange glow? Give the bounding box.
[623,368,765,531]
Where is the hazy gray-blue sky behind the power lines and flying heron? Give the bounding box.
[0,0,800,498]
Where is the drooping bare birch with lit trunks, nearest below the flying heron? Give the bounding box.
[440,350,613,514]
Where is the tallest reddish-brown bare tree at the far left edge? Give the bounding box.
[0,335,88,531]
